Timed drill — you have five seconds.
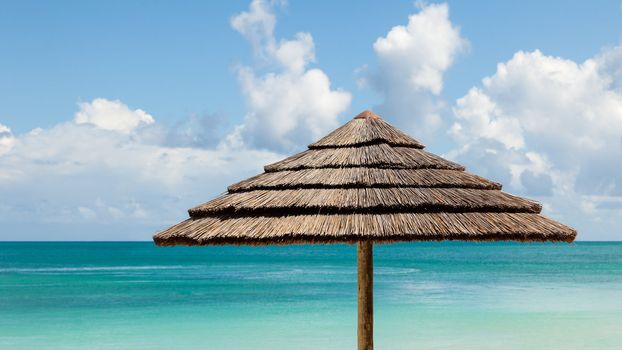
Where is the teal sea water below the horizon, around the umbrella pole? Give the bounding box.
[0,242,622,350]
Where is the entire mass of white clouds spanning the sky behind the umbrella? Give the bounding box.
[0,0,622,240]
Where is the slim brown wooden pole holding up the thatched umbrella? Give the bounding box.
[357,241,374,350]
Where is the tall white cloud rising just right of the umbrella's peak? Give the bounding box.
[369,3,468,138]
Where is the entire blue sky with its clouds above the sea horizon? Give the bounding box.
[0,1,622,240]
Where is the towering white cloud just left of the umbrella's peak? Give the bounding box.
[230,0,351,150]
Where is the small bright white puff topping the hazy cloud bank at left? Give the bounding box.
[74,98,154,133]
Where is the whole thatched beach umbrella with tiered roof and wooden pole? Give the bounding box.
[154,111,576,350]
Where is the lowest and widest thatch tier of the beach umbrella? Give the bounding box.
[154,213,575,245]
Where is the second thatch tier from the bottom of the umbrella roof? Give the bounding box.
[189,187,542,218]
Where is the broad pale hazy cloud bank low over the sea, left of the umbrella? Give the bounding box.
[0,99,280,240]
